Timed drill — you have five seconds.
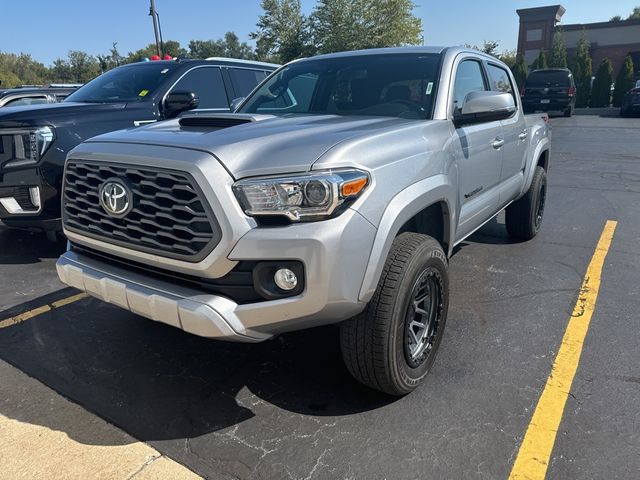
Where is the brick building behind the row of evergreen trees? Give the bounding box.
[517,5,640,77]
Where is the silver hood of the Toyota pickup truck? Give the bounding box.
[89,114,415,179]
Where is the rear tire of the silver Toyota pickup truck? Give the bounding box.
[506,165,547,240]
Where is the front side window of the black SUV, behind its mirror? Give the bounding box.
[171,67,229,109]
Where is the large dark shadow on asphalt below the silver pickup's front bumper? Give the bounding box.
[0,292,395,444]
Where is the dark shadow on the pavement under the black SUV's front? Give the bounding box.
[0,225,67,265]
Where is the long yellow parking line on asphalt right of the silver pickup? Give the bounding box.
[509,220,618,480]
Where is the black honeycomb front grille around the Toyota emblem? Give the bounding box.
[62,160,221,262]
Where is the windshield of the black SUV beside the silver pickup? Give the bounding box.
[64,63,172,103]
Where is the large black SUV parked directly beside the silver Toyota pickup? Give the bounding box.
[0,59,277,239]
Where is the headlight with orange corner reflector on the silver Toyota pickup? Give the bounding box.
[233,170,369,222]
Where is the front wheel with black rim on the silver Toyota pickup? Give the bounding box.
[340,233,449,395]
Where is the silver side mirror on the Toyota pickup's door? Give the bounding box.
[453,91,516,126]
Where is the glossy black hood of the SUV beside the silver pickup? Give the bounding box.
[0,102,127,127]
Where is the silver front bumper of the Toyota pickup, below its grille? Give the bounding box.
[56,210,376,342]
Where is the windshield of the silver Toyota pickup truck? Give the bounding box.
[238,53,440,119]
